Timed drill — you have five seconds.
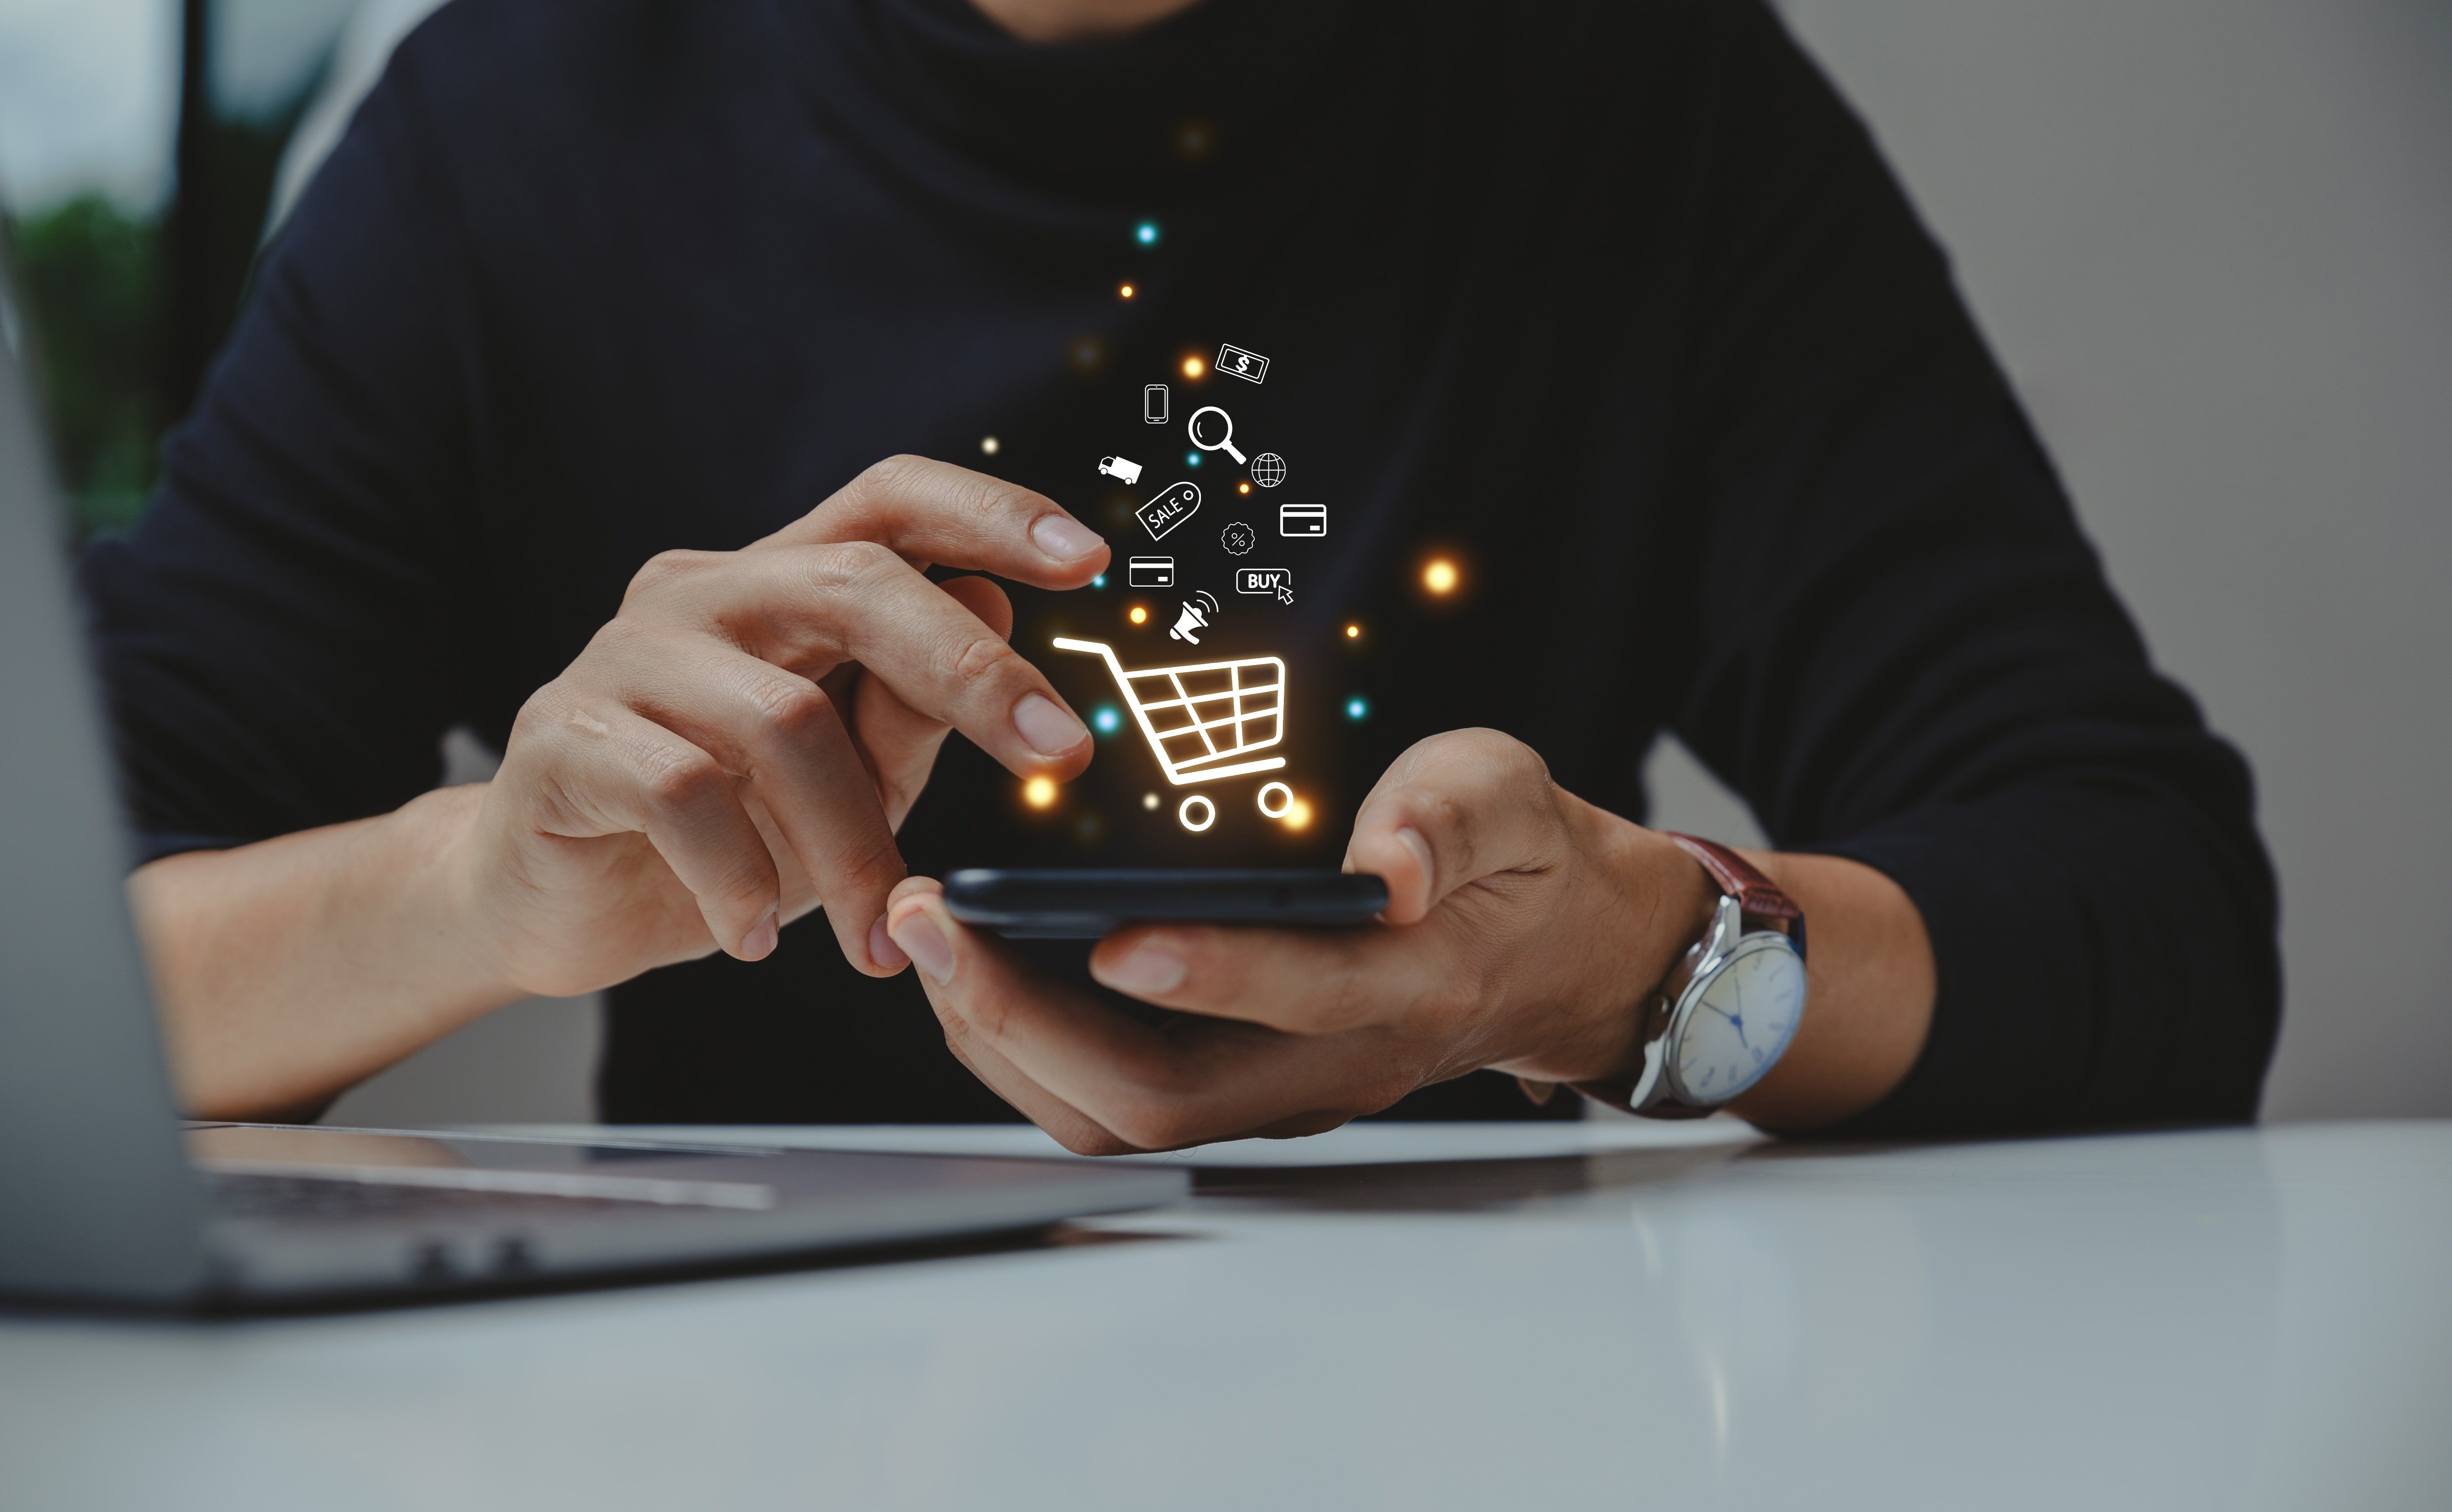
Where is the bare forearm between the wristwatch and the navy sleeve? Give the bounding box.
[1731,851,1934,1130]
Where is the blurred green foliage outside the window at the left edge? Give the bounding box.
[15,194,162,534]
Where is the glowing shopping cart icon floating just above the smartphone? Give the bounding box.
[1054,635,1295,833]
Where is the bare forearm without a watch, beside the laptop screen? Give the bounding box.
[128,784,522,1118]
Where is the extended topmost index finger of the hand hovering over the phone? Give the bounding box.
[750,456,1111,588]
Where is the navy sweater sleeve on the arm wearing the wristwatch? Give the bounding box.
[1675,5,2280,1135]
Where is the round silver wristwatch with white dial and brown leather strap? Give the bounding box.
[1574,831,1804,1118]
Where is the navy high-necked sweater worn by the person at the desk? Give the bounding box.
[86,0,2278,1132]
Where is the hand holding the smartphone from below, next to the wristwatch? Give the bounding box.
[888,730,1716,1154]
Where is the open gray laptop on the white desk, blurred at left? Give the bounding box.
[0,266,1187,1309]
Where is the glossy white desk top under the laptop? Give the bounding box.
[0,1123,2452,1512]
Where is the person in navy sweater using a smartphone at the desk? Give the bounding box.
[86,0,2278,1149]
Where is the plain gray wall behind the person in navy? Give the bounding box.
[336,0,2452,1123]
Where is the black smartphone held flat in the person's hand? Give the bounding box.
[944,868,1388,938]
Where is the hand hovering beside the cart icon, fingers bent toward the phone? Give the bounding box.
[449,456,1108,998]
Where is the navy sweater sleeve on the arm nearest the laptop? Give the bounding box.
[81,44,488,858]
